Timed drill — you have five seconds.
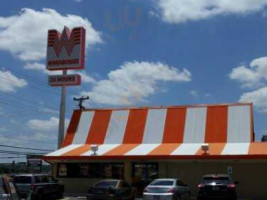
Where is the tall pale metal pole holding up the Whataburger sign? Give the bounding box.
[57,70,67,149]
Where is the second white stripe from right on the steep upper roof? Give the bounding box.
[184,107,207,143]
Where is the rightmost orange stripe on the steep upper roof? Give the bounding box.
[205,106,228,143]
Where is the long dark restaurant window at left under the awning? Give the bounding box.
[58,163,124,179]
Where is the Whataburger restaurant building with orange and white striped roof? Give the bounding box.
[44,103,267,199]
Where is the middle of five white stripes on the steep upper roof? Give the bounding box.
[143,109,167,144]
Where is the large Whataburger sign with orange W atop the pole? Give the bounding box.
[46,26,85,70]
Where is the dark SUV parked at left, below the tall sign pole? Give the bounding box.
[14,174,64,200]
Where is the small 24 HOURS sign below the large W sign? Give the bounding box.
[48,74,81,86]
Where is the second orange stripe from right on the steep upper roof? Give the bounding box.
[163,108,186,143]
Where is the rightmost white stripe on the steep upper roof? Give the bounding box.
[227,106,251,142]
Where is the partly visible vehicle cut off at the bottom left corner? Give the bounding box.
[0,175,20,200]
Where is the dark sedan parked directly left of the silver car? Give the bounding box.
[87,179,136,200]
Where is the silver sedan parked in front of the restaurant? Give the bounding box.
[143,178,190,200]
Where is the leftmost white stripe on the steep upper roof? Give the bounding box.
[72,111,95,144]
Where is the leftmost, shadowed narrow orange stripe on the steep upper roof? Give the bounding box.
[62,110,82,147]
